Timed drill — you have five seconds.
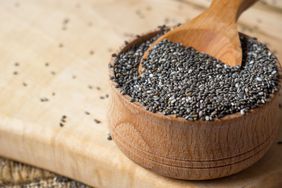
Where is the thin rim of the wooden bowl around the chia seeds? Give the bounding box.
[108,29,282,126]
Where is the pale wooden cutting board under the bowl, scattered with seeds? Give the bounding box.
[0,0,282,188]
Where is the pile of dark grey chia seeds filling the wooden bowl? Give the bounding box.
[111,28,279,121]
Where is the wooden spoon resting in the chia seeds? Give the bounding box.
[139,0,257,73]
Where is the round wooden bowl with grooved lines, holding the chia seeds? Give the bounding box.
[109,32,281,180]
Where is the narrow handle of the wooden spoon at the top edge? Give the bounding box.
[209,0,258,23]
